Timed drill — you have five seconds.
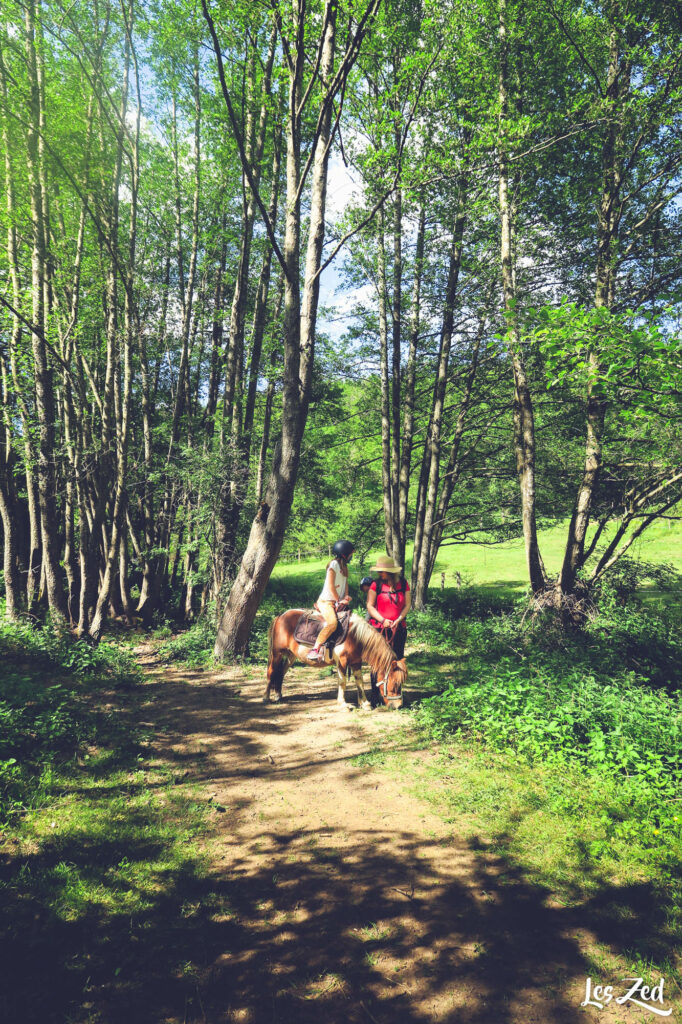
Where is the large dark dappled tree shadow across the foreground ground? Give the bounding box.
[0,828,666,1024]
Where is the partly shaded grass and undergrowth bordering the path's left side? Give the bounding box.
[0,626,215,1024]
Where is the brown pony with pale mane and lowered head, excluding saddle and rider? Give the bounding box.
[263,608,408,711]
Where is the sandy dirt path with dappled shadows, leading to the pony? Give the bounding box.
[138,648,655,1024]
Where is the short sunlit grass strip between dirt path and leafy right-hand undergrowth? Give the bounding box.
[411,740,682,993]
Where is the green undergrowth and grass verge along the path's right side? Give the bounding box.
[393,573,682,984]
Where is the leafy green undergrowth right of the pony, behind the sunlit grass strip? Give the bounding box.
[416,594,682,847]
